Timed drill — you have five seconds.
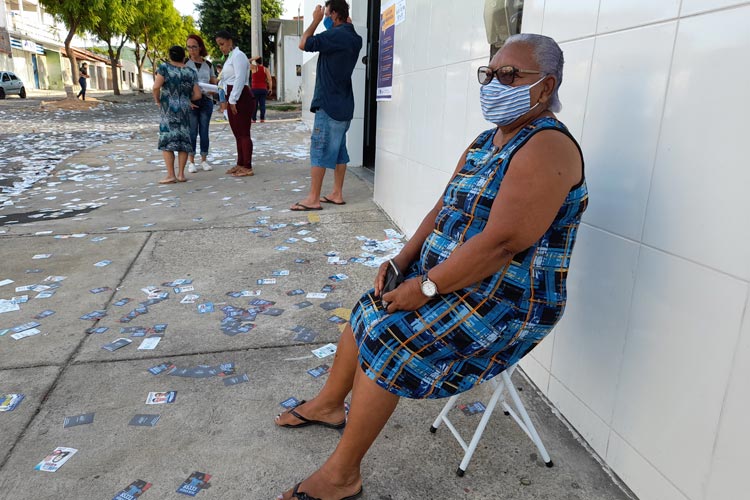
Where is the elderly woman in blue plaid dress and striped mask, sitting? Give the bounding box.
[276,34,588,500]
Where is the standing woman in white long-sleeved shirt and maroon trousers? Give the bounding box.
[216,30,255,177]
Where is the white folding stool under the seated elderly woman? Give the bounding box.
[430,364,553,477]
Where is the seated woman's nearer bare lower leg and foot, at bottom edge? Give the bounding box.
[282,367,398,499]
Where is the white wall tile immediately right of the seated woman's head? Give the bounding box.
[580,21,677,239]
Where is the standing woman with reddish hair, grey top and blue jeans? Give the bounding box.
[185,35,216,174]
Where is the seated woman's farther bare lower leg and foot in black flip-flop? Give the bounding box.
[276,324,358,425]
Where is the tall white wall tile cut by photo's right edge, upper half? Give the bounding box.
[643,4,750,281]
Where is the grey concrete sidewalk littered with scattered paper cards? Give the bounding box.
[0,110,633,500]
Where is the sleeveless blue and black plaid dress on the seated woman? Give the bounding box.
[351,118,588,399]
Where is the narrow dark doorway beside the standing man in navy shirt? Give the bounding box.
[362,0,380,170]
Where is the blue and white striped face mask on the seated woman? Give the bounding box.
[479,75,547,126]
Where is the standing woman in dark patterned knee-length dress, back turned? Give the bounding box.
[153,45,201,184]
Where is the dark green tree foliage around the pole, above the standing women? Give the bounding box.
[196,0,284,60]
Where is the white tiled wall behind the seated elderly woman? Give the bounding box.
[375,0,750,500]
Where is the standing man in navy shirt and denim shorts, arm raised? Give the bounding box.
[290,0,362,212]
